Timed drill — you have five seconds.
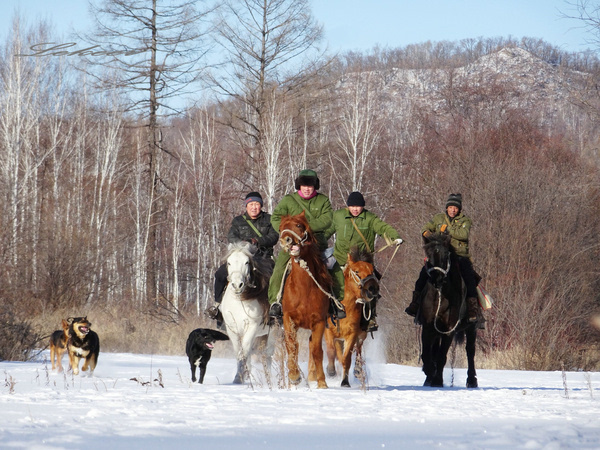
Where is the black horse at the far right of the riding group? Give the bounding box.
[419,233,477,388]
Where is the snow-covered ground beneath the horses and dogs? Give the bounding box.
[0,343,600,450]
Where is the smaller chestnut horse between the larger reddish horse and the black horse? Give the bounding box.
[325,248,379,387]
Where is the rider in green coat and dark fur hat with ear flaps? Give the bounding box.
[269,169,344,318]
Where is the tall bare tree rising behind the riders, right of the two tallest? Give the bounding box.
[212,0,326,203]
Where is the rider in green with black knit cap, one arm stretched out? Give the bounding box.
[325,192,403,331]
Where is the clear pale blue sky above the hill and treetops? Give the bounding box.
[0,0,590,51]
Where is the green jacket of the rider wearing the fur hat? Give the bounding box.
[271,192,333,250]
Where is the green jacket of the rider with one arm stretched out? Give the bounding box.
[325,208,400,266]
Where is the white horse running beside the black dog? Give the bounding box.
[221,242,273,384]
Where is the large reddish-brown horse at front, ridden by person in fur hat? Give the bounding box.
[279,212,332,388]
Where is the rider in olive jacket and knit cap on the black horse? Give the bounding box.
[405,194,479,322]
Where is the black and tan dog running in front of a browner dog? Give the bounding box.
[67,317,100,377]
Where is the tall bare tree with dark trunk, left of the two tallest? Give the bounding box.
[81,0,210,299]
